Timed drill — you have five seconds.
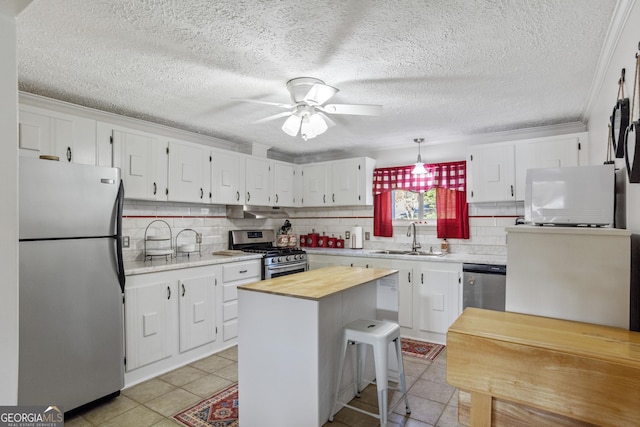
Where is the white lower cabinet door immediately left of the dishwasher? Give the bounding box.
[413,263,460,334]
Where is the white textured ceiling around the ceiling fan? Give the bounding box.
[17,0,616,155]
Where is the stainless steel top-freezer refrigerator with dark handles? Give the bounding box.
[18,158,125,412]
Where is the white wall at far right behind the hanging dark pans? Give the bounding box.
[587,0,640,233]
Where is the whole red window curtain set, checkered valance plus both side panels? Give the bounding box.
[373,161,469,239]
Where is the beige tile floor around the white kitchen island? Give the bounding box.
[65,347,460,427]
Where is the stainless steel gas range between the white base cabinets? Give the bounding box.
[229,230,309,279]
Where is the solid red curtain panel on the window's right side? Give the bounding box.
[436,188,469,239]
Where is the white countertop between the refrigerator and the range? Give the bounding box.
[124,253,262,276]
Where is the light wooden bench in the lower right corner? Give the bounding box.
[447,308,640,427]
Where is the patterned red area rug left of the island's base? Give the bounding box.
[173,383,239,427]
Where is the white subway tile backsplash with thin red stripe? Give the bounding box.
[123,200,522,261]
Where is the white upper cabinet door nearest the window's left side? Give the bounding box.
[330,157,375,206]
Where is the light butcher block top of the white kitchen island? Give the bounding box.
[238,266,398,300]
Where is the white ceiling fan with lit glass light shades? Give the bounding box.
[235,77,382,141]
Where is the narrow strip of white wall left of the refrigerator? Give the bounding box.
[0,10,18,405]
